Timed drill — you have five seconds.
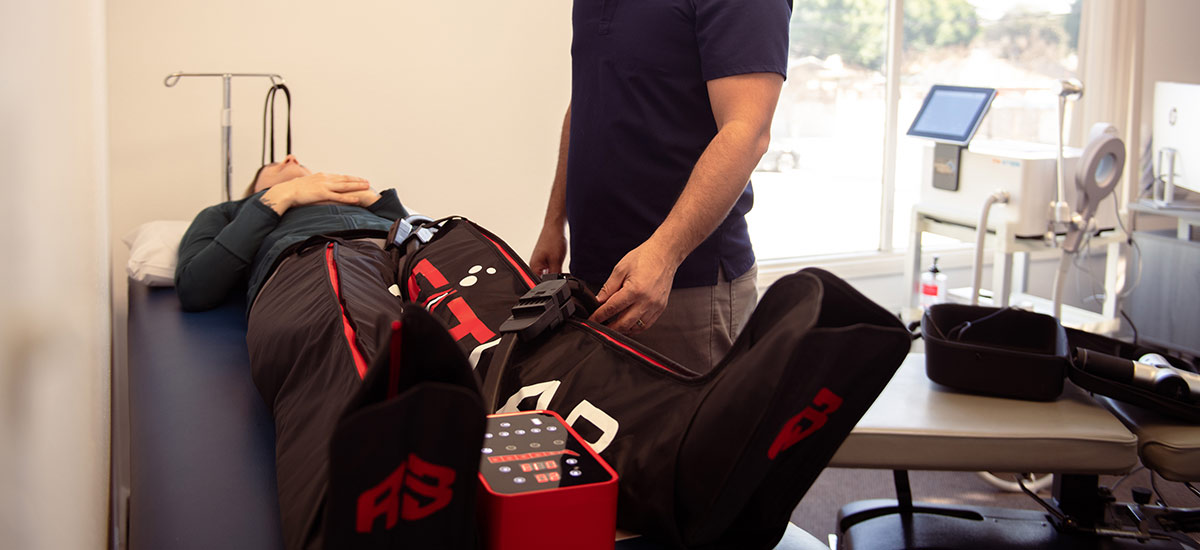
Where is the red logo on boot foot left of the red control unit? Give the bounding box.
[355,454,455,533]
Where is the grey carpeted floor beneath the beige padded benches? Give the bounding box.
[792,468,1200,543]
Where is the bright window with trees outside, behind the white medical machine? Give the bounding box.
[748,0,1081,261]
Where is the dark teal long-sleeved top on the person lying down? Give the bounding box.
[175,189,408,311]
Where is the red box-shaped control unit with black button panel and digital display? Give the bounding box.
[479,411,617,550]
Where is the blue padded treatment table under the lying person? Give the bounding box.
[128,281,832,550]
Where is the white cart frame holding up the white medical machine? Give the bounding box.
[905,204,1122,334]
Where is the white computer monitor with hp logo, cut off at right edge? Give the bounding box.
[1153,82,1200,210]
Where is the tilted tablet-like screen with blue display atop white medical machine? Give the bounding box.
[908,84,996,147]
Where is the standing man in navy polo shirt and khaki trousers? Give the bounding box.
[530,0,792,372]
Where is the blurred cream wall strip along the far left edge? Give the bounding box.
[0,0,110,549]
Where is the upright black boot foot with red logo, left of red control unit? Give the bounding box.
[324,307,486,550]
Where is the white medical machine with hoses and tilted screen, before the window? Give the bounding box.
[908,80,1126,318]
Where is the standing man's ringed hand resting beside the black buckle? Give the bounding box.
[590,239,679,334]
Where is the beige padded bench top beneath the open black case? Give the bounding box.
[829,353,1138,474]
